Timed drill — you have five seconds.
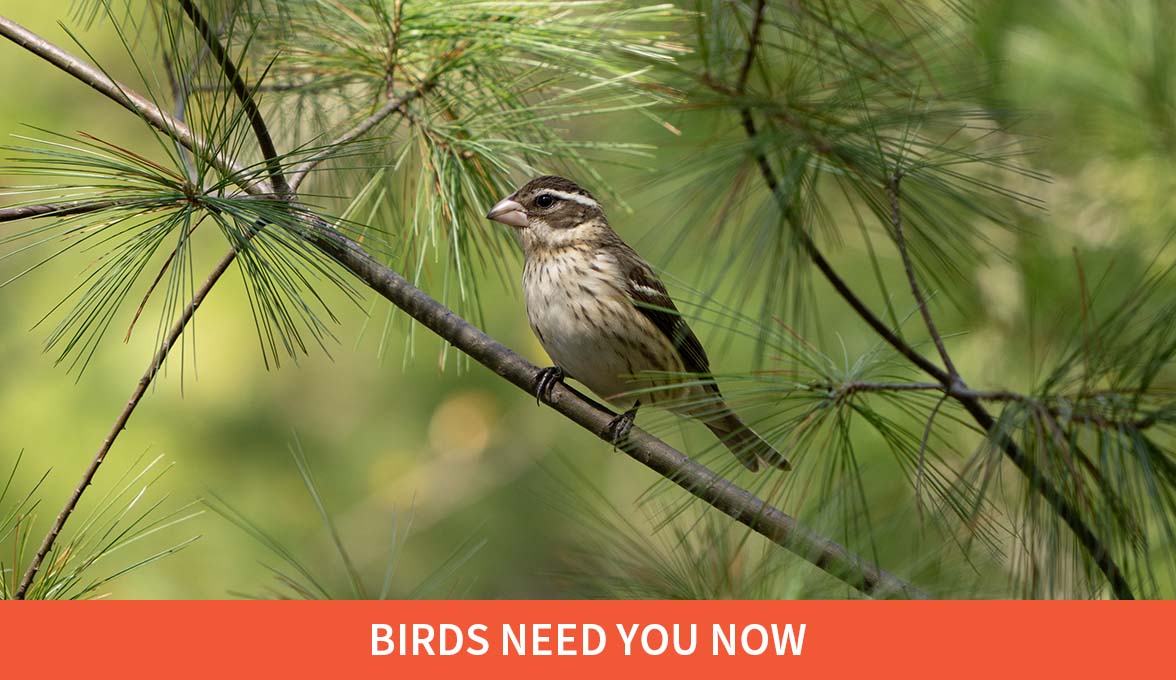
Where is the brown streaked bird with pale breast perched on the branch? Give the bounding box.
[486,175,790,472]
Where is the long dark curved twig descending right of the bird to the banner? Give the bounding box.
[735,0,1134,600]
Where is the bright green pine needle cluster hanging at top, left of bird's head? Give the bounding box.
[221,0,683,320]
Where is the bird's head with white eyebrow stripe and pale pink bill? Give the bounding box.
[486,175,608,253]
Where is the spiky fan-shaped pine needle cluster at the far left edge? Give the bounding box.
[0,126,350,371]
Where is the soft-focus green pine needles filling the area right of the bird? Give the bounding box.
[616,0,1176,596]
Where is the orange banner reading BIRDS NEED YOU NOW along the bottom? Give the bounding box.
[0,601,1161,680]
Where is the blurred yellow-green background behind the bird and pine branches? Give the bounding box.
[0,0,1176,598]
